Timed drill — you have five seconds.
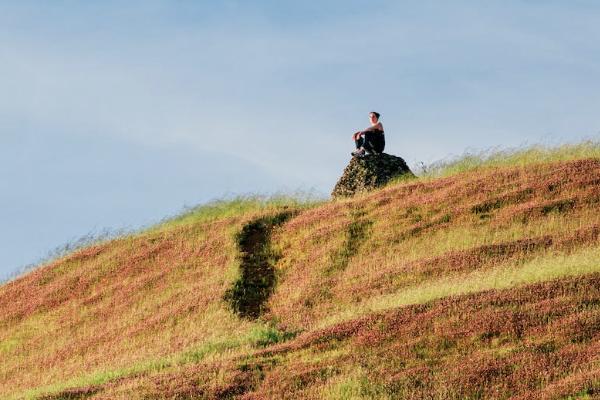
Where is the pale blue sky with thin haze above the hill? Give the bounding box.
[0,0,600,279]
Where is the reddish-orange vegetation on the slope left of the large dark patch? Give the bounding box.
[0,221,246,393]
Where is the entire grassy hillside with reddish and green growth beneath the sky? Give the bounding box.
[0,143,600,399]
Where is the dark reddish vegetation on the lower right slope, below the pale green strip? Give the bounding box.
[57,274,600,399]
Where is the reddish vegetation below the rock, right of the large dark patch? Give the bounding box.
[271,160,600,329]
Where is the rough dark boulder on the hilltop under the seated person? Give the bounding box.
[331,153,414,198]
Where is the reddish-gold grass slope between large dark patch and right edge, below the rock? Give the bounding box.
[270,153,600,329]
